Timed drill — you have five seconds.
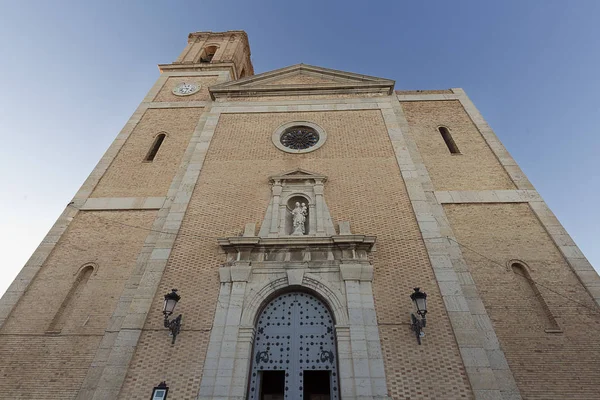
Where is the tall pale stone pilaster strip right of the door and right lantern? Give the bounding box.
[382,95,521,400]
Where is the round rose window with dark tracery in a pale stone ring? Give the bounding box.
[273,121,327,153]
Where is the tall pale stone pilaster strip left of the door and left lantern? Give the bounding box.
[77,70,234,400]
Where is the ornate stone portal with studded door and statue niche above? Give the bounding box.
[198,170,388,400]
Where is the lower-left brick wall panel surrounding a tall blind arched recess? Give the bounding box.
[0,211,156,400]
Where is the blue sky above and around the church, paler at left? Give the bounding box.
[0,0,600,293]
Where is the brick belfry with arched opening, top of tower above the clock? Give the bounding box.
[158,31,254,80]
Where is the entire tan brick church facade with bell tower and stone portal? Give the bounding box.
[0,31,600,400]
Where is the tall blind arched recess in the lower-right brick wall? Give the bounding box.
[510,262,560,332]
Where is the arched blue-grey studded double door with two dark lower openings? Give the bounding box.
[248,292,339,400]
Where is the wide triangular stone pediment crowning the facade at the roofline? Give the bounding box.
[209,64,395,98]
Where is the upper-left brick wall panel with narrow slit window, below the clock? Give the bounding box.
[91,108,203,197]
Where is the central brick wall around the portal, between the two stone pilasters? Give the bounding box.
[120,110,471,399]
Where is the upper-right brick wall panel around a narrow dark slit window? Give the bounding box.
[401,100,515,190]
